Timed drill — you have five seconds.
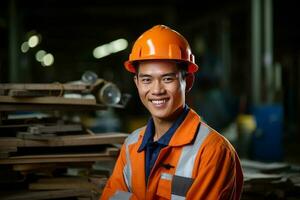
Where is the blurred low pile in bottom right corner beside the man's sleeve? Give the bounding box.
[242,160,300,200]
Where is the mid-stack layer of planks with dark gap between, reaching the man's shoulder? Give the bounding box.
[0,133,127,164]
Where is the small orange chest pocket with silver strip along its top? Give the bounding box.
[156,173,173,199]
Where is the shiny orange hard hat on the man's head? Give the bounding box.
[124,25,198,73]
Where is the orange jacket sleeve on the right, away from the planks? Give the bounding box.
[187,141,243,200]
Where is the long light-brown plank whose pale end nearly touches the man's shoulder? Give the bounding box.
[0,133,128,148]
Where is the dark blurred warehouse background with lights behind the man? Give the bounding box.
[0,0,300,198]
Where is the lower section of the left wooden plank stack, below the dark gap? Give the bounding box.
[0,120,128,200]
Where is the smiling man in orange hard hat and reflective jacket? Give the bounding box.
[101,25,243,200]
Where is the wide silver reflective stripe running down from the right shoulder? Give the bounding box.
[175,123,210,178]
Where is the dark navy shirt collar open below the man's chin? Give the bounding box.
[138,105,190,152]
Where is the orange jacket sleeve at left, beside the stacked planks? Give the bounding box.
[100,144,128,200]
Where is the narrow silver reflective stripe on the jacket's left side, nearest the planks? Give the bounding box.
[123,128,141,192]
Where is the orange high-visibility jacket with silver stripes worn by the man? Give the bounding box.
[101,109,243,200]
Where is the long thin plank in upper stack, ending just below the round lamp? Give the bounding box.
[0,96,96,105]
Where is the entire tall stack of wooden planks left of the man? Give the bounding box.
[0,82,128,200]
